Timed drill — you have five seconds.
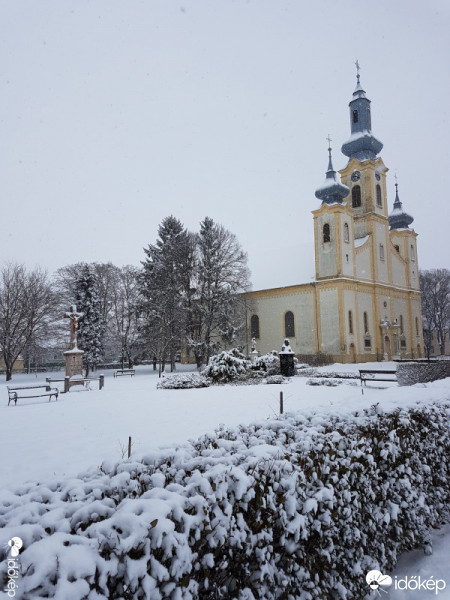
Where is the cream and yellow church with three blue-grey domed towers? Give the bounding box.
[247,67,423,362]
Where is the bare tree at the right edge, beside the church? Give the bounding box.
[420,269,450,357]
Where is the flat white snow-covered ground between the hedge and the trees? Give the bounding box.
[0,363,450,600]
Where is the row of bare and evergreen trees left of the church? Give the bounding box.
[0,216,250,380]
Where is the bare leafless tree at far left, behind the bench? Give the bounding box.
[0,263,55,381]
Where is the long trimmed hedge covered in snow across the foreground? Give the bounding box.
[0,403,450,600]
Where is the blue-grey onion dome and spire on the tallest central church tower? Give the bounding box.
[342,61,383,162]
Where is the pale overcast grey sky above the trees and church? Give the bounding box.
[0,0,450,289]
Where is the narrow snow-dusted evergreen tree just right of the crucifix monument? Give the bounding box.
[76,264,104,377]
